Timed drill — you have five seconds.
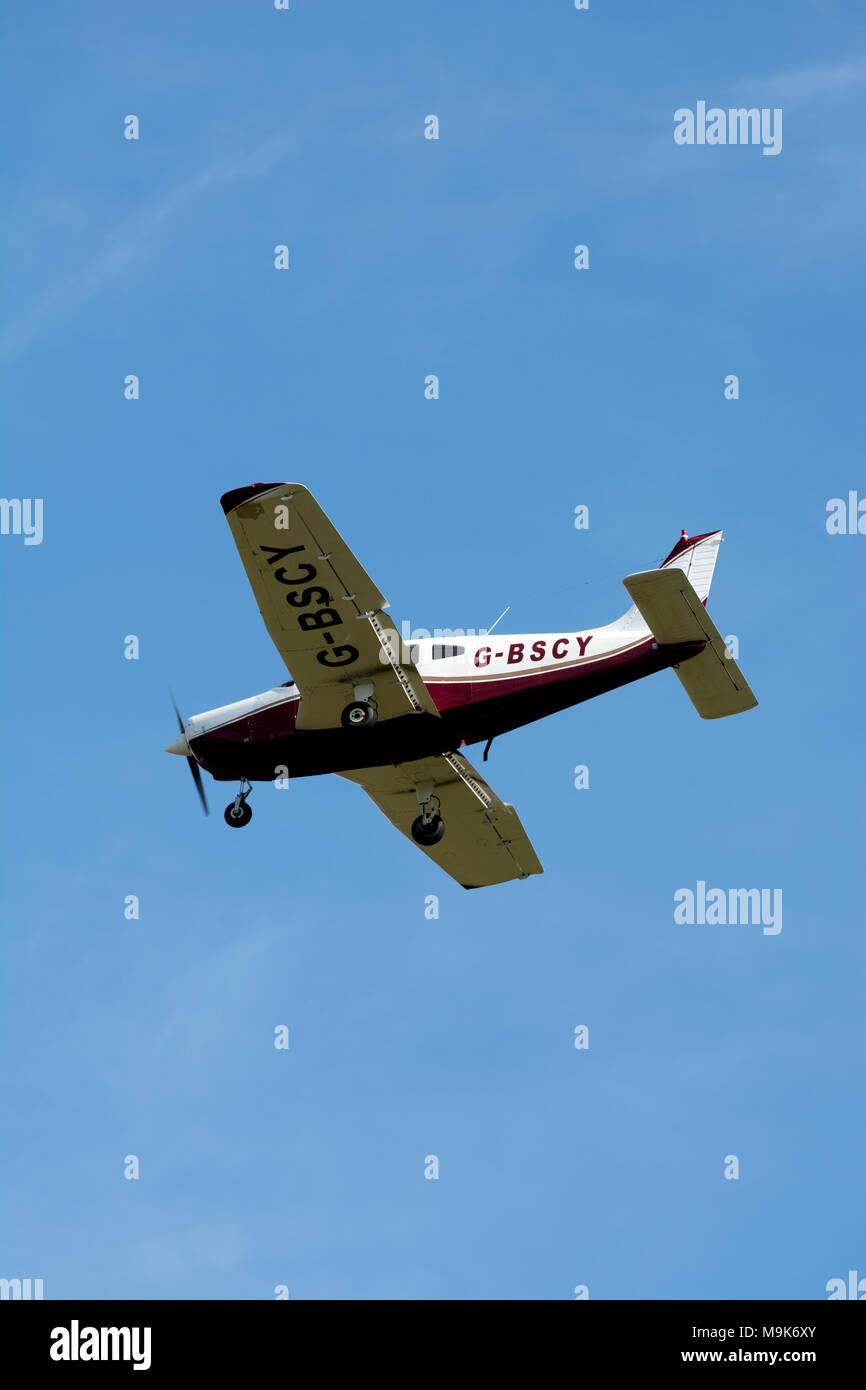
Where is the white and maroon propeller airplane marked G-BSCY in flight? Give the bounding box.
[165,482,758,888]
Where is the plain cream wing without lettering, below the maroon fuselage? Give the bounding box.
[338,753,544,888]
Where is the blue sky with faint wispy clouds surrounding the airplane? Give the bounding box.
[0,0,866,1300]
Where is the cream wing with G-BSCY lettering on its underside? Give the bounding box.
[220,482,438,730]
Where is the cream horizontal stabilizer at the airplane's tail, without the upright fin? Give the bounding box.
[623,569,758,719]
